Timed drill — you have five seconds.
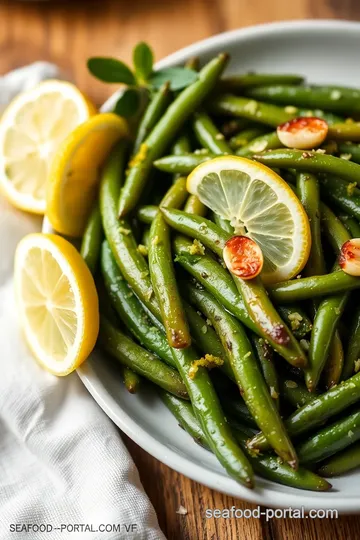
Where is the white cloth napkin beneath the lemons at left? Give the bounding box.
[0,62,165,540]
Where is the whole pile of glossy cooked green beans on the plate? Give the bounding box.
[81,58,360,491]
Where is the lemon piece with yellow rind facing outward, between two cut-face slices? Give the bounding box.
[46,113,128,237]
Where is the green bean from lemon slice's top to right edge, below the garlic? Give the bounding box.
[253,149,360,183]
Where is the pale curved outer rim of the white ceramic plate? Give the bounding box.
[76,19,360,514]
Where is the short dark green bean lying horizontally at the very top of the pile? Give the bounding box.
[217,73,304,92]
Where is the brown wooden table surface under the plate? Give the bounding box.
[0,0,360,540]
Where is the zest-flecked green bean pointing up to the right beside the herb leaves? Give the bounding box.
[119,54,228,217]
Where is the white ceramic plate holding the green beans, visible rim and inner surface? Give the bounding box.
[47,21,360,513]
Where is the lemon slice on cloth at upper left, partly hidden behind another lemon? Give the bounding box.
[0,80,96,214]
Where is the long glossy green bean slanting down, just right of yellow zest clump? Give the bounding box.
[186,284,297,468]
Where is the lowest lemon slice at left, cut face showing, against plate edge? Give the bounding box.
[15,233,99,375]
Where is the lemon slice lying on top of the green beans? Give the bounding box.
[187,156,311,283]
